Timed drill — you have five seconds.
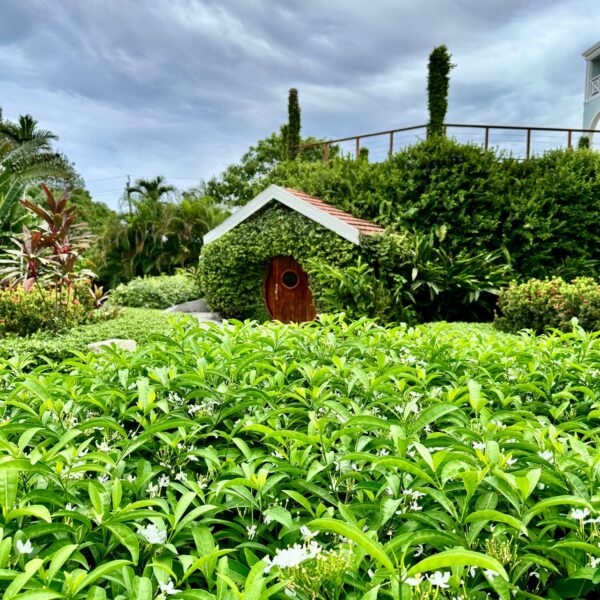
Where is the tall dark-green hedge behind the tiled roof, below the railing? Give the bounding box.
[266,138,600,277]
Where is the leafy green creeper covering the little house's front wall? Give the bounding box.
[200,204,359,321]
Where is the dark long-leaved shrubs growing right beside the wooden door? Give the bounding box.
[310,228,511,323]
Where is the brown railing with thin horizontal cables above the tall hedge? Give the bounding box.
[299,123,600,160]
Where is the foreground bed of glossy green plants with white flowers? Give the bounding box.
[0,316,600,600]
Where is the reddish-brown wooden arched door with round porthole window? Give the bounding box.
[265,256,317,323]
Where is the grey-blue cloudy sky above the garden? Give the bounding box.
[0,0,600,206]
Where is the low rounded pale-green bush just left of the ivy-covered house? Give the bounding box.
[110,272,202,308]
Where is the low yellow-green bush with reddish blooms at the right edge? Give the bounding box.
[494,277,600,333]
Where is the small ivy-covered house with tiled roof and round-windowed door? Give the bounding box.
[200,185,383,322]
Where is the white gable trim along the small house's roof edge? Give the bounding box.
[203,185,360,245]
